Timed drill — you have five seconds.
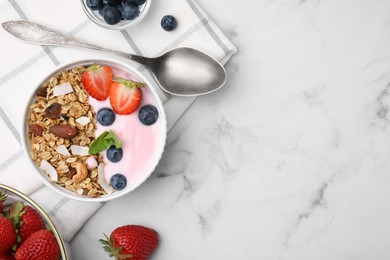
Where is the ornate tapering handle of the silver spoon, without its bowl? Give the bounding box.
[1,20,132,58]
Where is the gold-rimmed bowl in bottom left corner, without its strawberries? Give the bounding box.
[0,183,71,260]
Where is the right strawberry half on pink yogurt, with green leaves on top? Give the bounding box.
[110,78,144,115]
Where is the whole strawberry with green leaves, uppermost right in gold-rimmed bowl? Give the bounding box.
[9,202,45,241]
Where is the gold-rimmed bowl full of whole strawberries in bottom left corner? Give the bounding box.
[0,184,70,260]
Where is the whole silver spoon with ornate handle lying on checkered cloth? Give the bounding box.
[1,20,226,96]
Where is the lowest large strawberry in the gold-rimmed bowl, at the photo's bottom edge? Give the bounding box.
[15,229,61,260]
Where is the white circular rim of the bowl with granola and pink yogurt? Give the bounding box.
[21,58,167,202]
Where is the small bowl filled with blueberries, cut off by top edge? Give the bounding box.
[81,0,151,30]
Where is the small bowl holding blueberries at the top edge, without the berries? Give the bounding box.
[80,0,152,30]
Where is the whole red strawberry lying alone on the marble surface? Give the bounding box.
[100,225,159,260]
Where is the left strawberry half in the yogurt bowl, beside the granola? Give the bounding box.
[82,65,114,101]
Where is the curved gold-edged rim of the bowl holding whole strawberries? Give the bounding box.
[0,183,70,260]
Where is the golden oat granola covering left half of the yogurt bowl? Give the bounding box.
[28,66,106,198]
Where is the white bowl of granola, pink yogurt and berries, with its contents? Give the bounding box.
[22,58,167,202]
